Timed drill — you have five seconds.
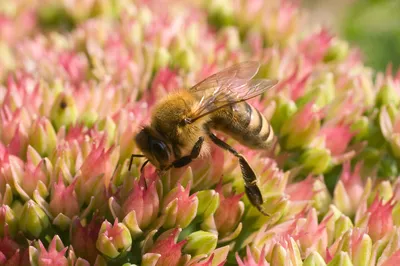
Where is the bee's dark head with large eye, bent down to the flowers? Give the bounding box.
[135,127,171,170]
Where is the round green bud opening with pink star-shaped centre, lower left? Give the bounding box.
[96,219,132,258]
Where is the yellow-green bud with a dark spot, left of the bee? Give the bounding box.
[50,93,78,130]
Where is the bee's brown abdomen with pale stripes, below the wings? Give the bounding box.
[209,102,274,149]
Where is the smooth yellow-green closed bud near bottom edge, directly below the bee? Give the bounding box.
[183,231,218,256]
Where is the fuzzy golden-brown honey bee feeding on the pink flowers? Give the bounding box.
[131,62,277,215]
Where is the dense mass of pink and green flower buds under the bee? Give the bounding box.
[0,0,400,266]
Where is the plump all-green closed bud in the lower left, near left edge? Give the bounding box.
[19,200,50,238]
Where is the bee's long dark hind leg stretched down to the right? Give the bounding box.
[208,132,269,216]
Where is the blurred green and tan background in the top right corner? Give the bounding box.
[301,0,400,71]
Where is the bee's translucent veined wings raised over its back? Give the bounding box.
[187,62,277,122]
